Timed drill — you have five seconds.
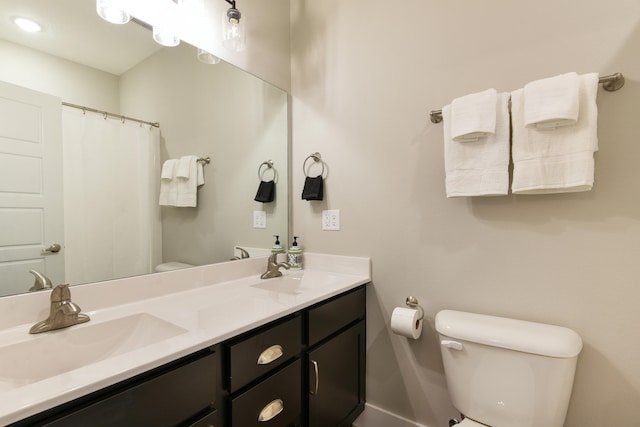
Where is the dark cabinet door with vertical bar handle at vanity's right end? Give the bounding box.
[308,321,365,427]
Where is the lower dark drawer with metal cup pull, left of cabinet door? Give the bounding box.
[231,359,302,427]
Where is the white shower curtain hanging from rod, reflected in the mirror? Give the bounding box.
[62,107,162,284]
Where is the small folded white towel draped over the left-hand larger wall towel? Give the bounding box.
[449,89,498,142]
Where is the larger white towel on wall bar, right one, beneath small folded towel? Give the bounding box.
[511,73,598,194]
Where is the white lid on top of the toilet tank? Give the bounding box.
[436,310,582,358]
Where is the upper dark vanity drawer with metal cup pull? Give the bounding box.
[229,316,302,393]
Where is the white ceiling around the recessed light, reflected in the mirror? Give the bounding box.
[0,0,162,75]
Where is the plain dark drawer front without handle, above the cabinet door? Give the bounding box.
[309,286,367,346]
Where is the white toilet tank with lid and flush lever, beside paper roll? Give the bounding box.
[436,310,582,427]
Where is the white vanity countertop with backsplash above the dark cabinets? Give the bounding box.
[0,254,371,425]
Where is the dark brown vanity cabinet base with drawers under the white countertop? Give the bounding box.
[11,285,366,427]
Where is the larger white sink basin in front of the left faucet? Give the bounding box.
[0,313,186,391]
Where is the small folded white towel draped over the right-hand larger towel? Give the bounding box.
[524,73,580,129]
